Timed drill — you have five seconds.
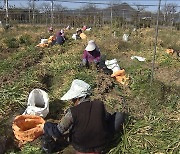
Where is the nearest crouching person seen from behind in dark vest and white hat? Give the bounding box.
[43,79,125,154]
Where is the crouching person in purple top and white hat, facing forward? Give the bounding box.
[82,40,101,67]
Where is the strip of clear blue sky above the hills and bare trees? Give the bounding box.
[1,0,180,12]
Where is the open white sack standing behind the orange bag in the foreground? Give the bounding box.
[23,89,49,118]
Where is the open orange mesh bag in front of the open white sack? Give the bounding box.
[12,115,45,144]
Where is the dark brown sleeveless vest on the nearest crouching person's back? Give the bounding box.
[71,101,109,152]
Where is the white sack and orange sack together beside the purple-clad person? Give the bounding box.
[105,59,129,85]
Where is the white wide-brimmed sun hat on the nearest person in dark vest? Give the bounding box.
[61,79,91,100]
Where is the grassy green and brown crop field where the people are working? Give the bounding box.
[0,26,180,154]
